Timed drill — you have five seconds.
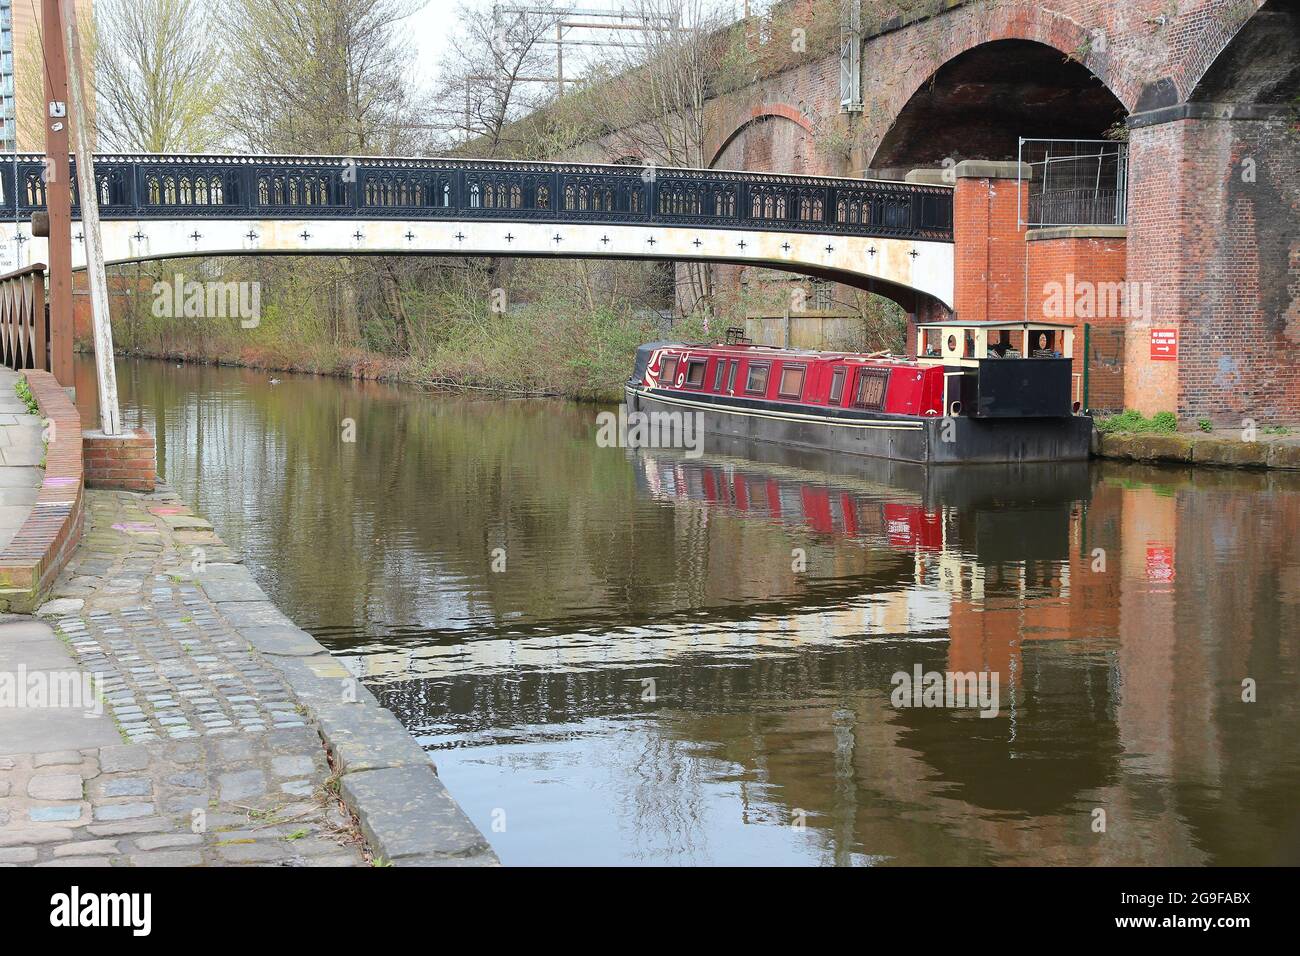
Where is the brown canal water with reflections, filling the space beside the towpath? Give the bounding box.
[79,362,1300,865]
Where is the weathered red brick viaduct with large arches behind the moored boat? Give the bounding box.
[571,0,1300,424]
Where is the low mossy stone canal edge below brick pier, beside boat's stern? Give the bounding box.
[1092,428,1300,471]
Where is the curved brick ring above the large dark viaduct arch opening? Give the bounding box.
[863,4,1141,165]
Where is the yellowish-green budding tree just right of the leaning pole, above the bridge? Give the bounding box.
[95,0,221,152]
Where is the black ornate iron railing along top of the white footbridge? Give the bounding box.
[0,153,953,242]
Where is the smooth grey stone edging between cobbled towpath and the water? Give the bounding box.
[171,502,501,866]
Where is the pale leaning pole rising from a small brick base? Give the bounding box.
[62,0,122,434]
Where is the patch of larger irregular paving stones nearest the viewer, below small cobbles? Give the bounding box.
[0,728,365,866]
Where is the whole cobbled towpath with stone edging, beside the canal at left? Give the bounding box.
[0,488,495,866]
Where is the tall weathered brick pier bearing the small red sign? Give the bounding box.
[1126,118,1300,427]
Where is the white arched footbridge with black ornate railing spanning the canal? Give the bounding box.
[0,153,953,311]
